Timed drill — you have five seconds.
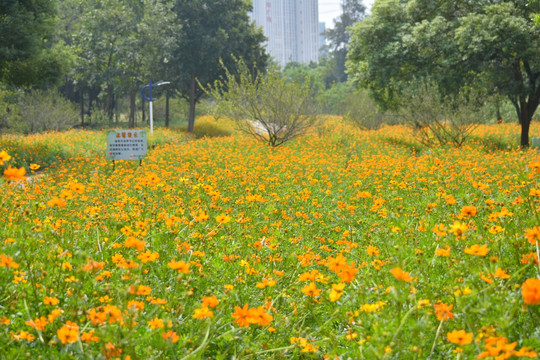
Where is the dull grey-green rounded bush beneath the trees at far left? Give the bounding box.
[9,90,78,134]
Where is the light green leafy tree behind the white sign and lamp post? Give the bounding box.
[64,0,178,127]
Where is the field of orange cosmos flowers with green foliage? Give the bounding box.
[0,121,540,359]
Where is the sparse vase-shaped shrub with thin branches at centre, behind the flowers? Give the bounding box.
[207,61,318,147]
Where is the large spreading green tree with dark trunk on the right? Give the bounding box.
[348,0,540,147]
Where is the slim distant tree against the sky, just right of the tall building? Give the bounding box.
[325,0,366,84]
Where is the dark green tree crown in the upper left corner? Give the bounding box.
[0,0,65,86]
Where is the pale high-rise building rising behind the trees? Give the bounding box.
[251,0,320,66]
